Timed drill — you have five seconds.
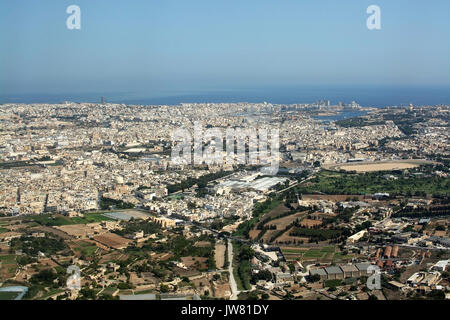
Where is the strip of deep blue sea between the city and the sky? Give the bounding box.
[0,84,450,108]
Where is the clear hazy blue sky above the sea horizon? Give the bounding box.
[0,0,450,96]
